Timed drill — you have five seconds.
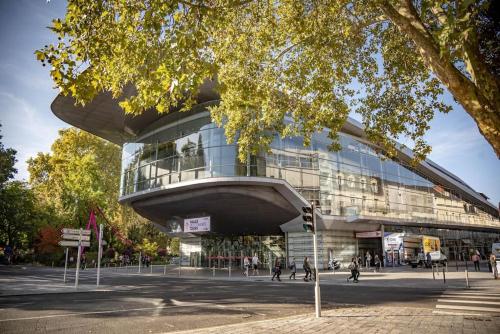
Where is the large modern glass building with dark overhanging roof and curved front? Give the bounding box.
[52,83,500,266]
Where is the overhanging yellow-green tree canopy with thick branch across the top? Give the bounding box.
[36,0,500,160]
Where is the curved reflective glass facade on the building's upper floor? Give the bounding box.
[121,112,500,228]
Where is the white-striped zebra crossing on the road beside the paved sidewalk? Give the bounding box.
[433,289,500,316]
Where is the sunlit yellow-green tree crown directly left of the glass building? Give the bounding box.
[28,128,121,226]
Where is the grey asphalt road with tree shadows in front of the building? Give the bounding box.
[0,267,450,334]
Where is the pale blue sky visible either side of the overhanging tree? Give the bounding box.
[0,0,500,205]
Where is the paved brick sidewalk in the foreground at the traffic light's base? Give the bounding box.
[169,307,500,334]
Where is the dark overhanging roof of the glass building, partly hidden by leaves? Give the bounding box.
[51,86,499,217]
